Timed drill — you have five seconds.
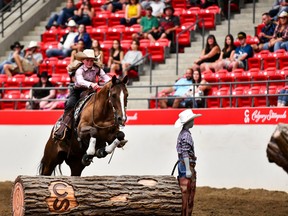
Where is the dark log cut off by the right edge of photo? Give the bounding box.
[266,123,288,173]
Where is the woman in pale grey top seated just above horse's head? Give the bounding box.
[122,40,143,79]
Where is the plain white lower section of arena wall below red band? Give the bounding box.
[0,125,288,192]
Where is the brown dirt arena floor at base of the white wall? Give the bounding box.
[0,182,288,216]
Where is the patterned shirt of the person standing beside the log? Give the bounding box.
[176,128,196,163]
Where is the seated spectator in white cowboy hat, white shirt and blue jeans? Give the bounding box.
[46,20,78,58]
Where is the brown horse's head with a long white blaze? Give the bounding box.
[109,76,128,126]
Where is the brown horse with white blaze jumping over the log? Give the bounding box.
[39,76,128,176]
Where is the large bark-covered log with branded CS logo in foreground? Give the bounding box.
[12,176,182,216]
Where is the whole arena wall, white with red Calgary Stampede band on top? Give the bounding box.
[0,107,288,192]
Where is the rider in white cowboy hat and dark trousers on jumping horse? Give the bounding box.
[54,49,111,140]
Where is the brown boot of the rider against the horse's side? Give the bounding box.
[53,109,73,140]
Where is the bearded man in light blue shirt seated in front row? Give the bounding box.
[159,68,192,109]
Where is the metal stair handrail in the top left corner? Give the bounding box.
[0,0,46,38]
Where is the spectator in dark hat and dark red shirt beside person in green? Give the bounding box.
[148,6,180,45]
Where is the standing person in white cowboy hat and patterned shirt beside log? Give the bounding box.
[174,109,202,216]
